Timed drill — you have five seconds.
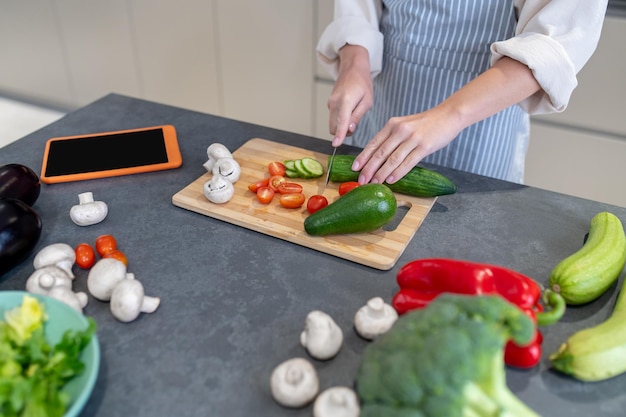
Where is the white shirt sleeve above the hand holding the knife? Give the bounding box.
[316,0,383,78]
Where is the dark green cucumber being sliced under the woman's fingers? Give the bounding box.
[329,155,456,197]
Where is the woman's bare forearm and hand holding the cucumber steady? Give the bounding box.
[352,57,540,184]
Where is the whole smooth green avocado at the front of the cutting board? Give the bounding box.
[304,184,398,236]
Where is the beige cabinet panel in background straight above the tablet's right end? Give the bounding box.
[129,0,223,114]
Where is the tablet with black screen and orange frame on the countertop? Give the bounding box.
[40,125,182,184]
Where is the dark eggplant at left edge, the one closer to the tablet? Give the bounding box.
[0,164,41,206]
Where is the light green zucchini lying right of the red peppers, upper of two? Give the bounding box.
[550,211,626,305]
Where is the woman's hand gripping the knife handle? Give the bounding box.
[328,45,374,147]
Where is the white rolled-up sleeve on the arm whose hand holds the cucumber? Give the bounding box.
[491,0,607,114]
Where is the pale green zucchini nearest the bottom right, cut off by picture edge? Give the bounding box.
[549,266,626,381]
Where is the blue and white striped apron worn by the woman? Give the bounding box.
[346,0,529,183]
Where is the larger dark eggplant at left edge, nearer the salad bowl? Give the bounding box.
[0,198,41,276]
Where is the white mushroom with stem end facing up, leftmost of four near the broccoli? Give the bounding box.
[270,358,319,408]
